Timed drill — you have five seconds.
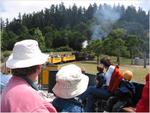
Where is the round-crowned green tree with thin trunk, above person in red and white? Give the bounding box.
[103,29,127,64]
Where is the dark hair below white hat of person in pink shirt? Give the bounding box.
[12,66,37,76]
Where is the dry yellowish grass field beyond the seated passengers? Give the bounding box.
[59,59,149,83]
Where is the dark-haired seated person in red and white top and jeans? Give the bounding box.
[81,58,122,112]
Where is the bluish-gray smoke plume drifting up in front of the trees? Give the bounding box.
[91,5,121,39]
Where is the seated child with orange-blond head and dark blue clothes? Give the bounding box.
[106,70,135,112]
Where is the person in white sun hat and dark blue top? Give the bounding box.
[52,64,89,112]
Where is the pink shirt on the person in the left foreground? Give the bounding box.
[1,76,56,112]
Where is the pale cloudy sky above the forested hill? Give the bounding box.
[0,0,150,21]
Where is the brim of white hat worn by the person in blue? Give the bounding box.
[52,74,89,99]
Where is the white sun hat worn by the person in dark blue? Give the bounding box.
[53,64,89,99]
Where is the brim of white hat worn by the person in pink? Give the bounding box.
[6,53,48,69]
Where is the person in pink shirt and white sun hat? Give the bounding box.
[1,39,56,112]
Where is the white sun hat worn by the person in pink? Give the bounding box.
[6,39,48,69]
